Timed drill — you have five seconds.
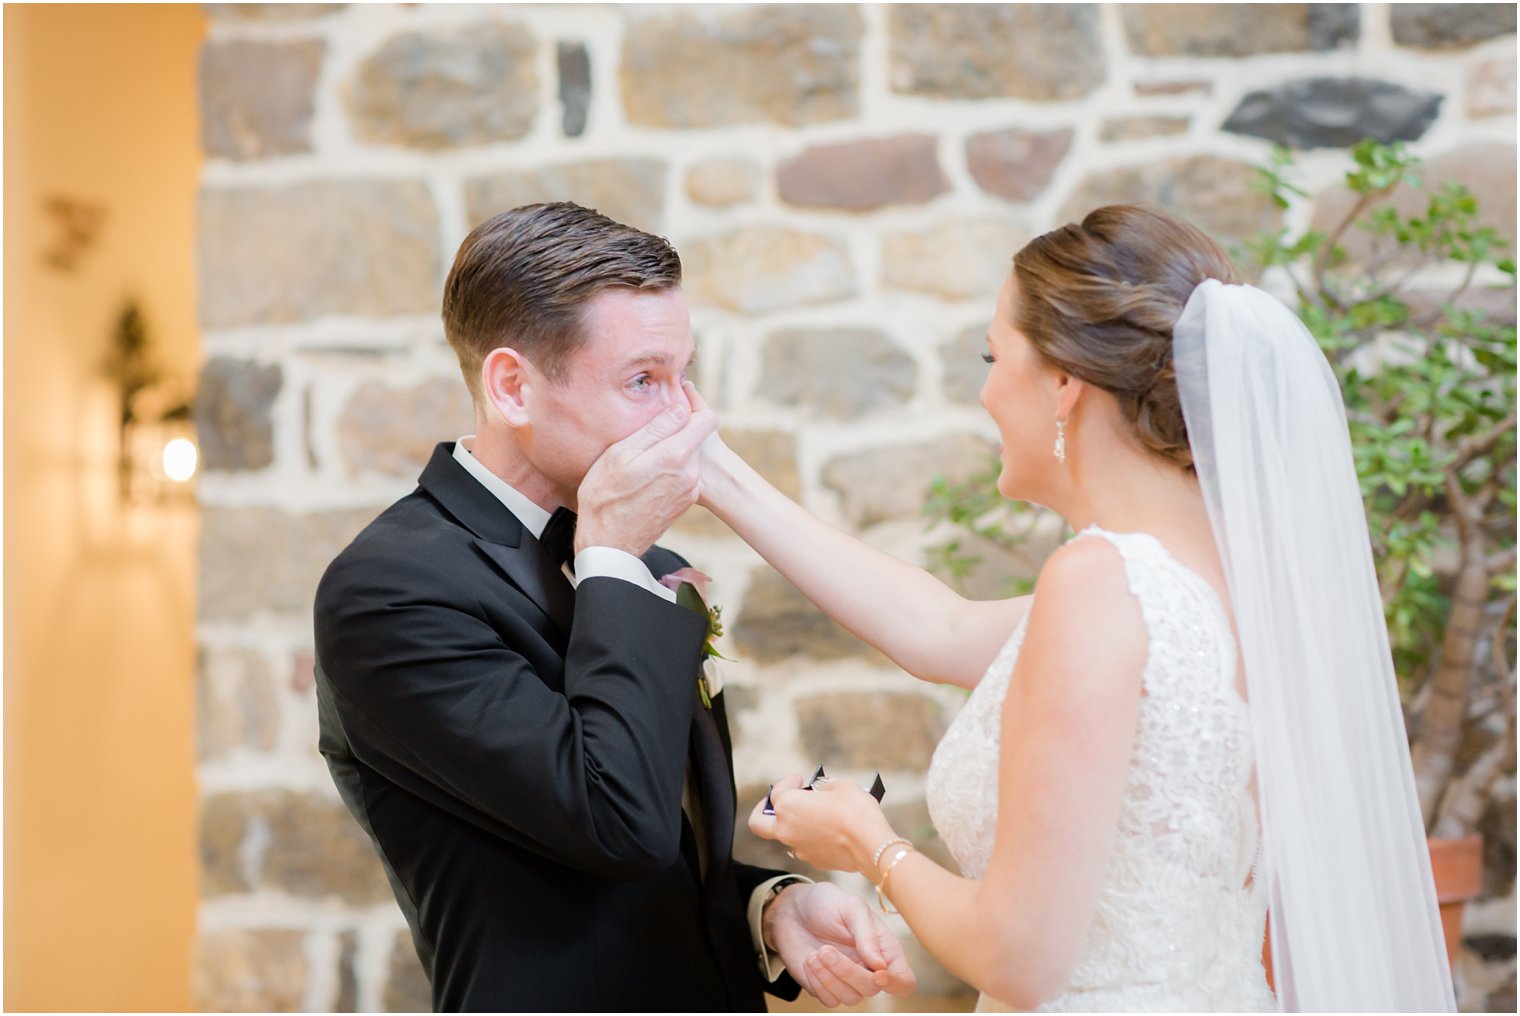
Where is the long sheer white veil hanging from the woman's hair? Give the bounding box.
[1173,280,1455,1011]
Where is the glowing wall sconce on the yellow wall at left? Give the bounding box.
[108,300,201,503]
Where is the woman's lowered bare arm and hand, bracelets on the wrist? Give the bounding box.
[751,540,1146,1008]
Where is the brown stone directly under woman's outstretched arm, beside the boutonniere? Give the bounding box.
[727,567,885,665]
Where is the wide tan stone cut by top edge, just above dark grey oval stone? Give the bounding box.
[1122,3,1360,56]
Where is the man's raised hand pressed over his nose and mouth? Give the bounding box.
[575,400,717,557]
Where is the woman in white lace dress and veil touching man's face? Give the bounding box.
[693,207,1453,1010]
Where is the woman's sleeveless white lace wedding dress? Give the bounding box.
[927,526,1277,1011]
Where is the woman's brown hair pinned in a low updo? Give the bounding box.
[1012,205,1236,471]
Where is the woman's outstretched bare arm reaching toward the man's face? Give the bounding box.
[699,425,1029,687]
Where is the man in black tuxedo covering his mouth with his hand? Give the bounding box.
[315,204,914,1011]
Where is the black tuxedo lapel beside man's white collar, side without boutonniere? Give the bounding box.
[416,441,575,637]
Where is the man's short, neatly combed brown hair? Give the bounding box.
[444,202,681,405]
